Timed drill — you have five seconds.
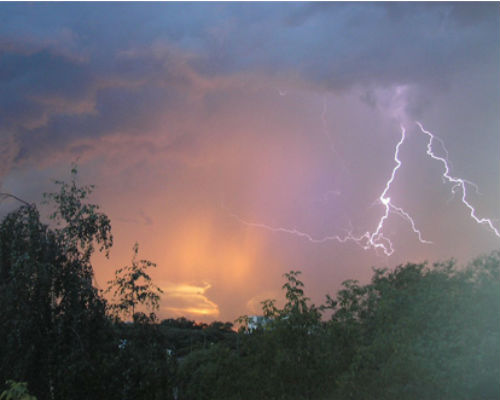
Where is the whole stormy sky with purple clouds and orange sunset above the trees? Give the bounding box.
[0,2,500,321]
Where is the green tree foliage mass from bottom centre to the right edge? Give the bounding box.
[180,253,500,400]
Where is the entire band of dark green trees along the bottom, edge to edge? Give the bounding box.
[0,173,500,400]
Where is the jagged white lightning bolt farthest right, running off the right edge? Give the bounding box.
[416,121,500,237]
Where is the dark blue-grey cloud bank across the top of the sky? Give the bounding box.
[0,3,499,174]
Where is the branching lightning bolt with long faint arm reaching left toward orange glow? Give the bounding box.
[231,126,431,256]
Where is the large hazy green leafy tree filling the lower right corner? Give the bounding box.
[331,254,500,399]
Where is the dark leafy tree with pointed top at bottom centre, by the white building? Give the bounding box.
[187,271,330,399]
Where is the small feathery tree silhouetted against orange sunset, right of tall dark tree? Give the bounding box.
[106,243,163,319]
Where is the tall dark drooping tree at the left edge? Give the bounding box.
[0,169,180,400]
